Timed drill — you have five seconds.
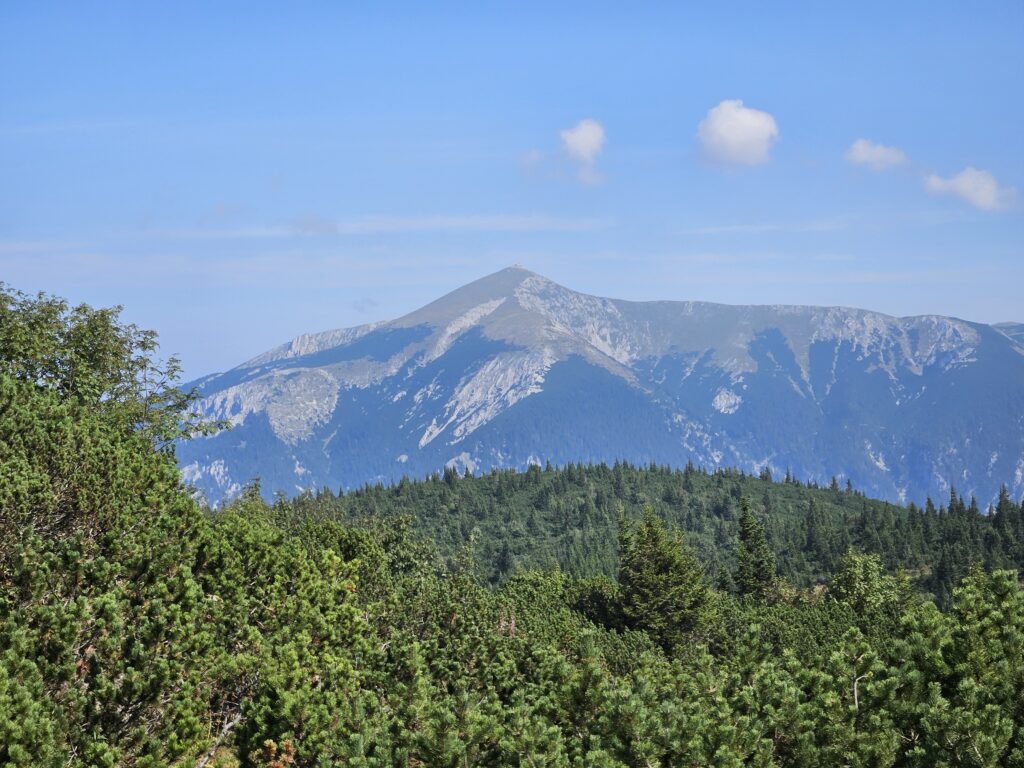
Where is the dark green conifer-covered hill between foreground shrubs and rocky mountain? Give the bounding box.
[278,463,1024,603]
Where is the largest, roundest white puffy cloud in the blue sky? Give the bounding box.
[697,98,779,165]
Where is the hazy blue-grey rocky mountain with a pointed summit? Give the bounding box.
[178,267,1024,502]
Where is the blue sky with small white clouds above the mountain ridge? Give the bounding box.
[0,2,1024,376]
